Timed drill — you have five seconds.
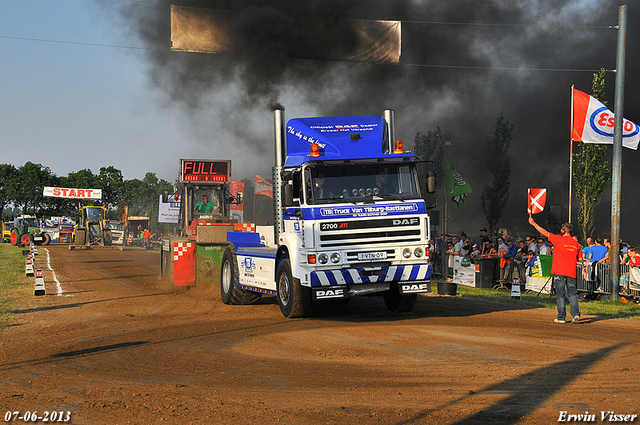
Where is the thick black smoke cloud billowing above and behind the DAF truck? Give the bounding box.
[116,0,640,242]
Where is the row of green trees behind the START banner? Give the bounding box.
[0,162,174,228]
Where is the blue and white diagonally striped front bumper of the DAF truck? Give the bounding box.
[309,264,431,286]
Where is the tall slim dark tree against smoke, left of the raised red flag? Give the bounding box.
[480,112,513,235]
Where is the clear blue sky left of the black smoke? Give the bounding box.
[0,0,192,181]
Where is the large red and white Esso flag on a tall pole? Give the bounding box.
[571,88,640,150]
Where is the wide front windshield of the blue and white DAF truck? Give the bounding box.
[305,164,420,204]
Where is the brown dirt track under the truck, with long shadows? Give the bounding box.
[0,245,640,424]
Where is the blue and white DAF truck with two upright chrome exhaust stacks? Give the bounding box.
[220,109,435,317]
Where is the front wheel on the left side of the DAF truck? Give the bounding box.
[276,258,311,318]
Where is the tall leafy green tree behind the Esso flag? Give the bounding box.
[573,69,611,243]
